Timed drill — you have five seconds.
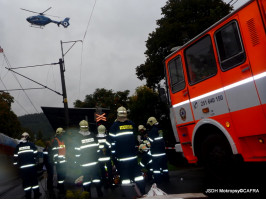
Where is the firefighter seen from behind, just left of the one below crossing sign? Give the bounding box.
[75,120,103,197]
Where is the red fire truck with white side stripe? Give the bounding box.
[164,0,266,174]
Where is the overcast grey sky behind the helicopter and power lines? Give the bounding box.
[0,0,248,116]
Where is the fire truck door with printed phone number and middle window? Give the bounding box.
[184,35,229,121]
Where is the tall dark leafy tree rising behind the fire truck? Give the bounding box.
[136,0,232,88]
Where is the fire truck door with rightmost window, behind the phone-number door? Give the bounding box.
[215,18,265,137]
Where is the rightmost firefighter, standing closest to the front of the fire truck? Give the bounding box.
[147,117,169,183]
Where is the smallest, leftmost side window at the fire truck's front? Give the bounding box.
[168,56,186,93]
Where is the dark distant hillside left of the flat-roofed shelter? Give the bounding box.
[18,113,54,139]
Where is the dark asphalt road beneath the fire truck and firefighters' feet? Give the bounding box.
[0,165,266,199]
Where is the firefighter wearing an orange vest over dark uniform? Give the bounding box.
[52,127,66,195]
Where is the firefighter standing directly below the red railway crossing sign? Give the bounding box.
[96,125,113,187]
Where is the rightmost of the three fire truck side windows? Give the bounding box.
[215,21,246,71]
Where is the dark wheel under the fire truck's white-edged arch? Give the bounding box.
[201,134,233,180]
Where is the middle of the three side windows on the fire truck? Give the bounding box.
[185,36,217,85]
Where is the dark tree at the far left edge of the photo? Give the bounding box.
[0,92,22,138]
